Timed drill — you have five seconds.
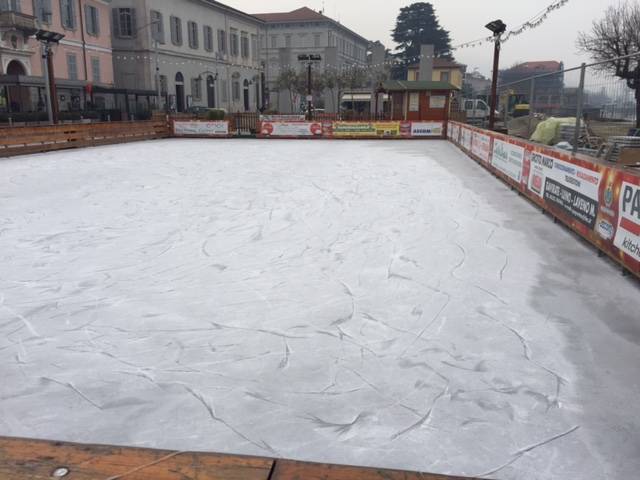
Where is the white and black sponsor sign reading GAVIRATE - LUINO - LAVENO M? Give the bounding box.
[529,152,601,230]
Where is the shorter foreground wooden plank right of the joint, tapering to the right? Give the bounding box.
[271,460,478,480]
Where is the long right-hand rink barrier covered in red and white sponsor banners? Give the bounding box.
[447,122,640,277]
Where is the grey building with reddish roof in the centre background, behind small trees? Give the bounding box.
[254,7,371,112]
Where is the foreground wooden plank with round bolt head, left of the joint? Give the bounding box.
[0,437,273,480]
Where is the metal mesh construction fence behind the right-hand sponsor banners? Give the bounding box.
[452,54,640,156]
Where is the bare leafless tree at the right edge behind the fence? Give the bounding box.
[578,1,640,128]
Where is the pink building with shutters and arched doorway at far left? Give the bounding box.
[0,0,113,114]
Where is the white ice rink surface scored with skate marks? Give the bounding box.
[0,140,640,480]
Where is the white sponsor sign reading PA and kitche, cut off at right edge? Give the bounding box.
[613,182,640,261]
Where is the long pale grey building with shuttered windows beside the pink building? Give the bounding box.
[111,0,264,112]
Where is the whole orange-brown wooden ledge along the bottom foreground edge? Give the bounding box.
[0,437,480,480]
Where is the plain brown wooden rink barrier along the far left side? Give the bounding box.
[0,119,171,157]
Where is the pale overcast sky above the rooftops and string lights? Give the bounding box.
[229,0,619,75]
